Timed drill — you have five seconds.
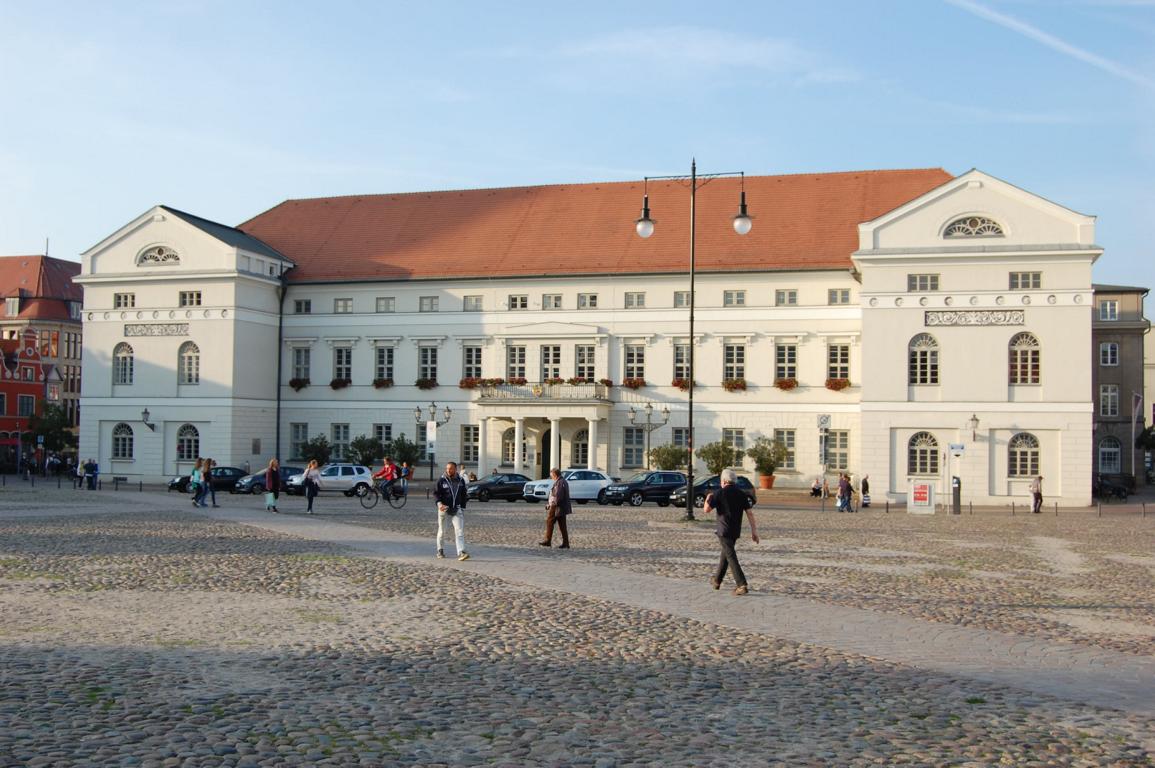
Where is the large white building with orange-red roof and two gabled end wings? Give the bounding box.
[77,170,1102,504]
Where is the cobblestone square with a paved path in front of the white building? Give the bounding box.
[0,485,1155,767]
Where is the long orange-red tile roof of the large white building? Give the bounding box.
[238,169,952,282]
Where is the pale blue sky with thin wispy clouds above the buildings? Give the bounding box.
[0,0,1155,286]
